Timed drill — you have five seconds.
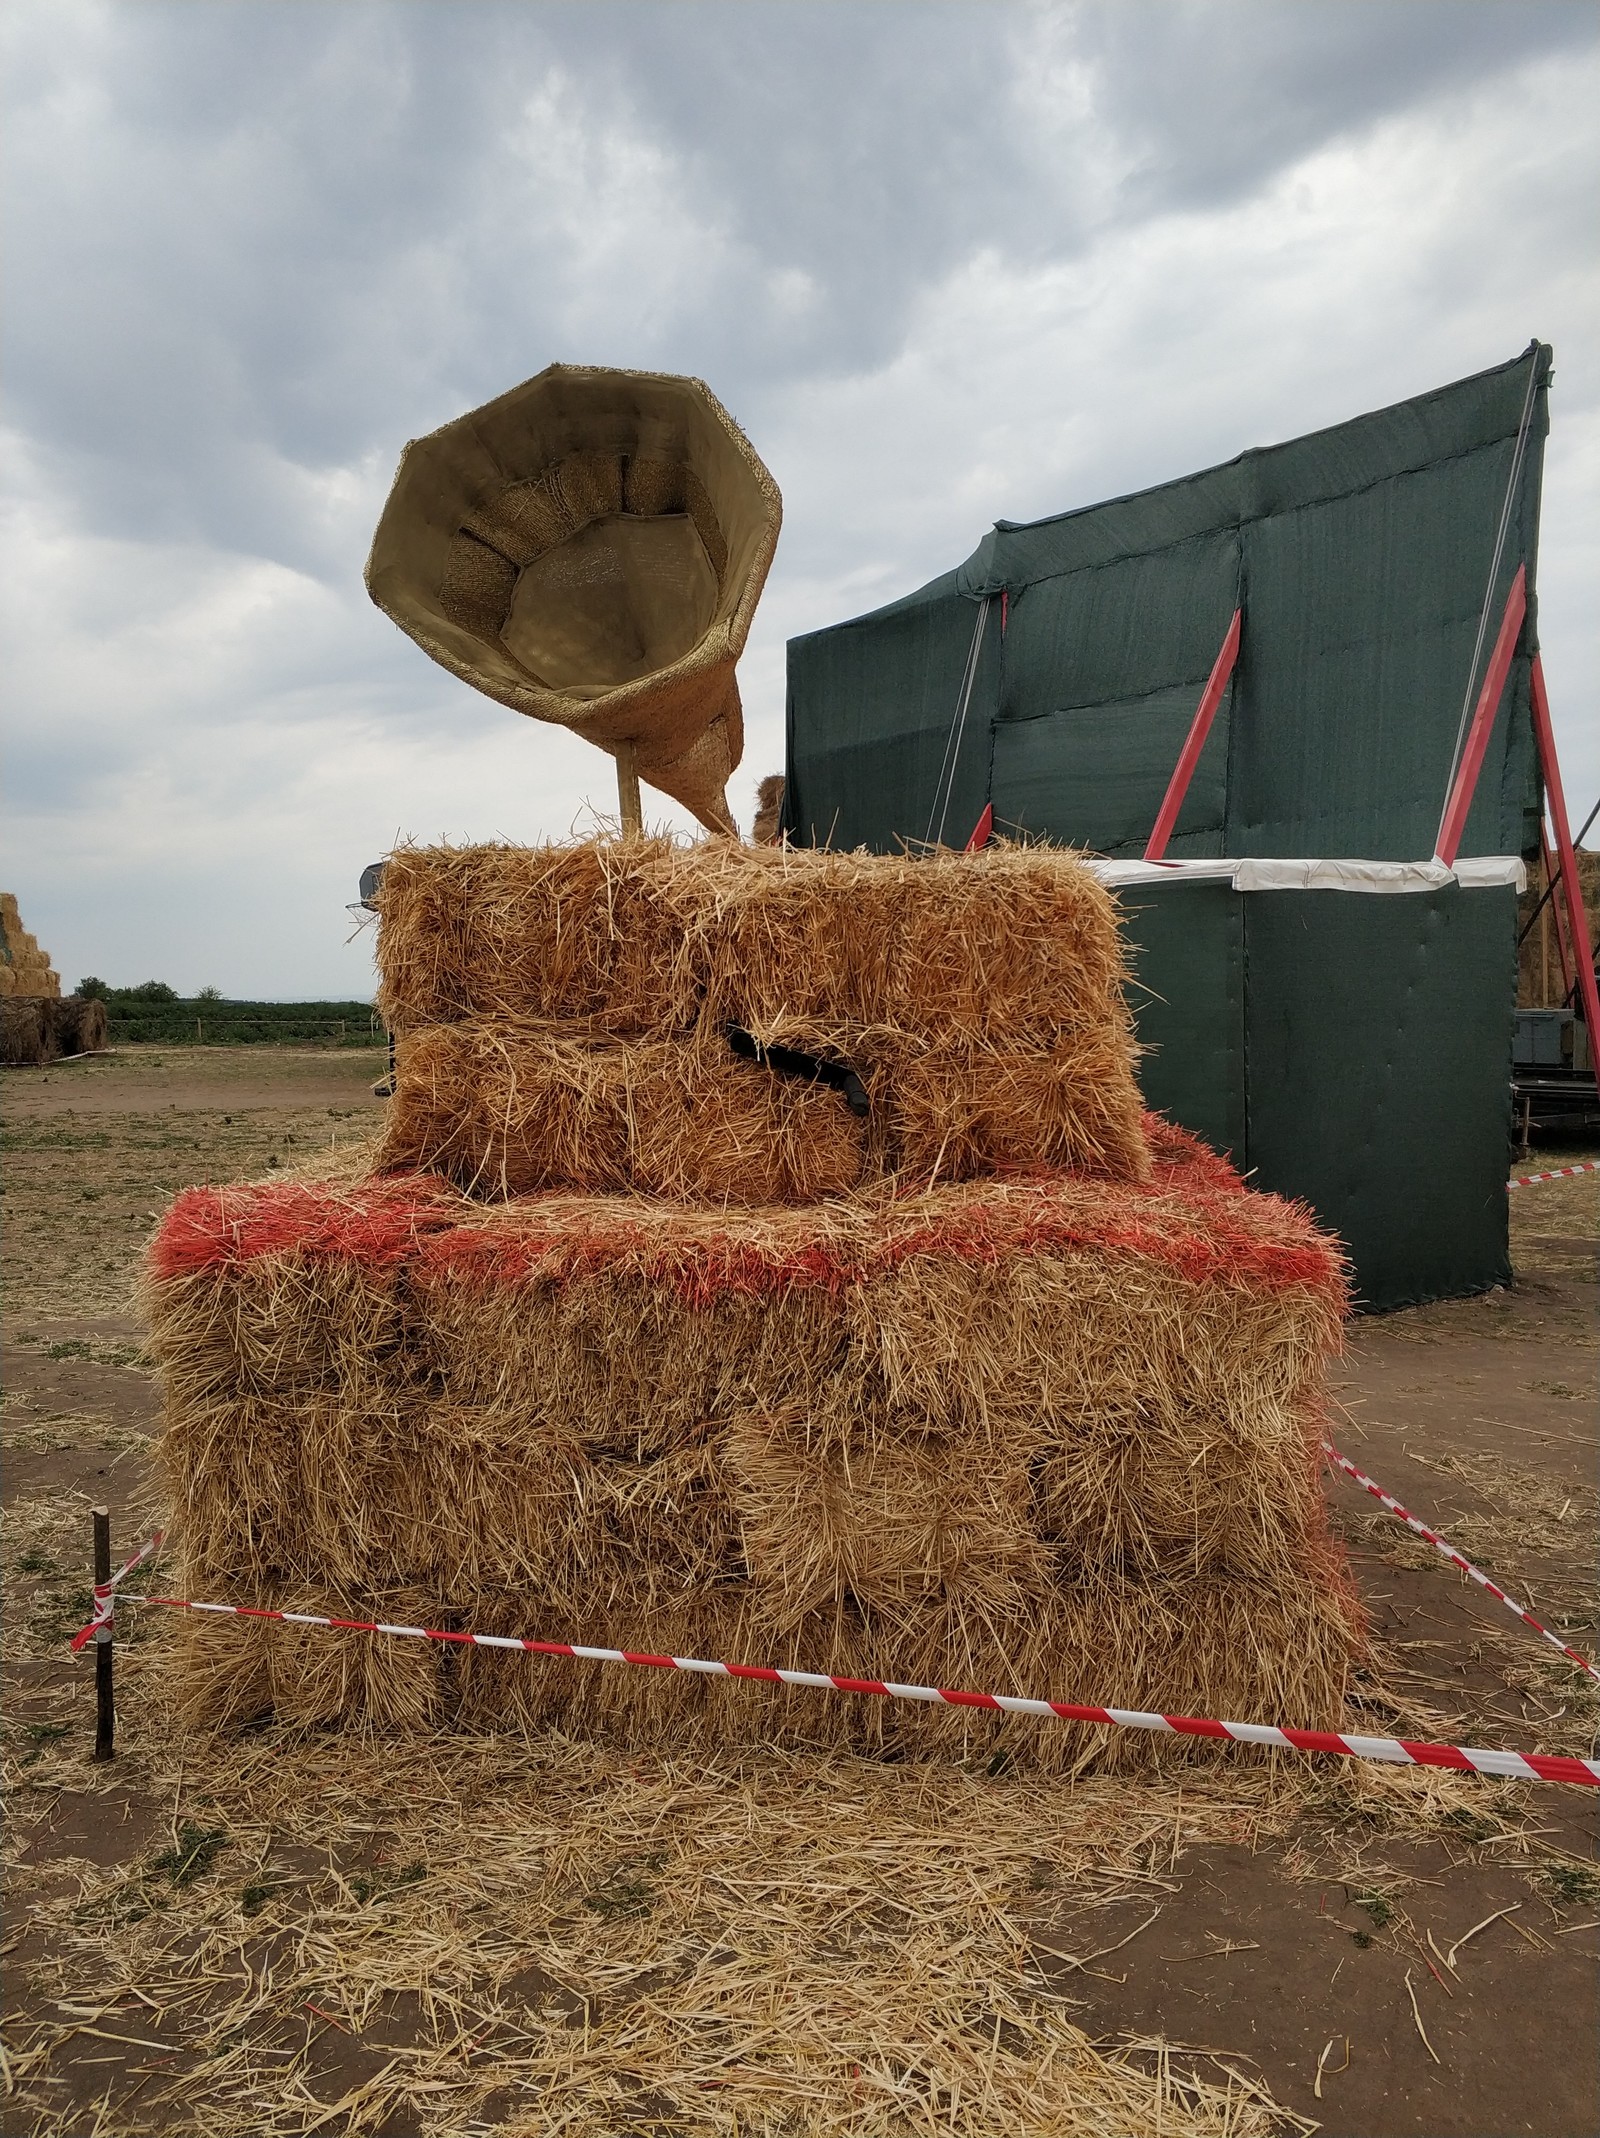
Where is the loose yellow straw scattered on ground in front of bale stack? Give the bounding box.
[0,1636,1360,2138]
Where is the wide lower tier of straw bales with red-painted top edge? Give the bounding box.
[150,1122,1356,1762]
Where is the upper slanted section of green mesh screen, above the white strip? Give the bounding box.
[785,344,1551,862]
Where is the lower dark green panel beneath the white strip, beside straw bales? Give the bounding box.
[1121,879,1517,1308]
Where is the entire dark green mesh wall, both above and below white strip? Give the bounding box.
[785,342,1551,1308]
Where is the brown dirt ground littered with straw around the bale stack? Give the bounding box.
[0,1048,1600,2138]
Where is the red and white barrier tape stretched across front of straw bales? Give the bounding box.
[96,1597,1600,1790]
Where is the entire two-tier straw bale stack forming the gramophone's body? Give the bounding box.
[150,842,1356,1766]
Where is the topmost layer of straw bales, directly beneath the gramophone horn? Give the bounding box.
[379,840,1132,1047]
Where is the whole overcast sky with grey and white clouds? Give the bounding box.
[0,0,1600,996]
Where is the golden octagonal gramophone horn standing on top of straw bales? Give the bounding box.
[366,363,783,832]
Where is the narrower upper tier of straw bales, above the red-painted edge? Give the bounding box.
[379,840,1147,1206]
